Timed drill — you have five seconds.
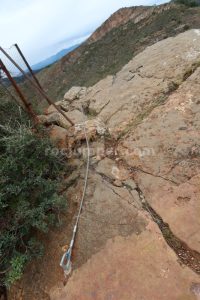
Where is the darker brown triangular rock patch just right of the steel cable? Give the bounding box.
[69,171,148,267]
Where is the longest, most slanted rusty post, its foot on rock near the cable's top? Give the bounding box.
[0,47,74,126]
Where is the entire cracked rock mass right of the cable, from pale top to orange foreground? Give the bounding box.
[48,30,200,300]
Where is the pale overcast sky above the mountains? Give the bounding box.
[0,0,166,64]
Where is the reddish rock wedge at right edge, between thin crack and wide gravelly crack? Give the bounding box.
[134,174,200,252]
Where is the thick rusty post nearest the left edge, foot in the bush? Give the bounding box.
[0,59,37,123]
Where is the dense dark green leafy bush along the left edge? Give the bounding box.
[0,103,65,286]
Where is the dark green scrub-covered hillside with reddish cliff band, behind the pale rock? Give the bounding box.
[19,3,200,106]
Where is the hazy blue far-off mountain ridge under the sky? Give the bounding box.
[32,44,80,71]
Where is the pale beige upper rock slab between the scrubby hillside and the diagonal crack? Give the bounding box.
[67,30,200,137]
